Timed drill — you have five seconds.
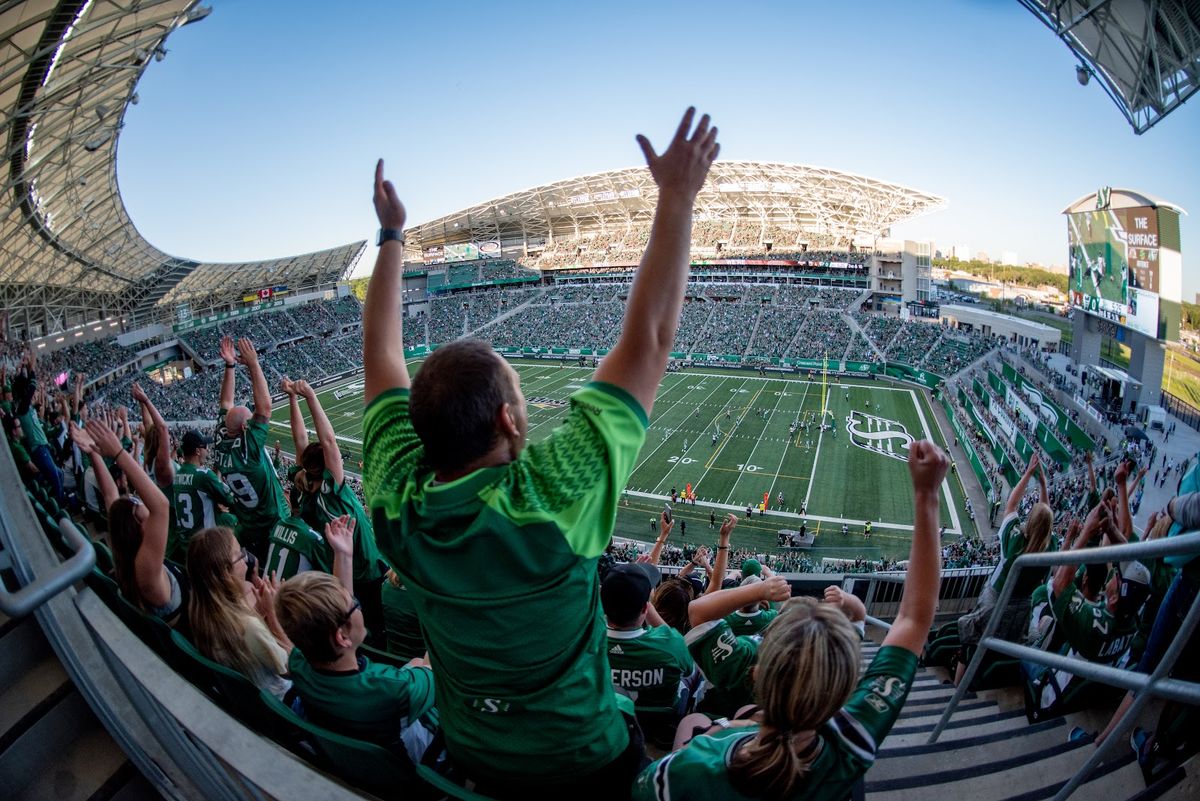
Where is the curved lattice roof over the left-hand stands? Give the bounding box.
[0,0,365,336]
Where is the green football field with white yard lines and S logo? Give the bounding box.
[271,362,976,560]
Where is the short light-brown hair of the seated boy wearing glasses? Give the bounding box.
[275,571,348,663]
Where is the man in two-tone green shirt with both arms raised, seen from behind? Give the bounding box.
[362,109,718,797]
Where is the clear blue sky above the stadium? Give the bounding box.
[118,0,1200,293]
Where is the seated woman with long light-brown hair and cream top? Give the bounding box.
[187,528,292,700]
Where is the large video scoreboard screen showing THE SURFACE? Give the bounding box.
[1067,206,1162,337]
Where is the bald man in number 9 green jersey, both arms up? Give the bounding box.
[216,337,287,560]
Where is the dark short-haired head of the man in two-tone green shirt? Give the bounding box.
[409,339,517,470]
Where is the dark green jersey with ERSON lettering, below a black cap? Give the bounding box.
[608,626,696,712]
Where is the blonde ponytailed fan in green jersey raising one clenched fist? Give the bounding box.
[634,441,949,801]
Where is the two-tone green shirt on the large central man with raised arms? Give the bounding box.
[364,383,647,784]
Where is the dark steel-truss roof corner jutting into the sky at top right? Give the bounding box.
[1020,0,1200,133]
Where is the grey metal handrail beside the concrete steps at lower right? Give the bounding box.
[928,531,1200,801]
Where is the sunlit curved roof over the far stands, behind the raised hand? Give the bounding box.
[406,161,946,247]
